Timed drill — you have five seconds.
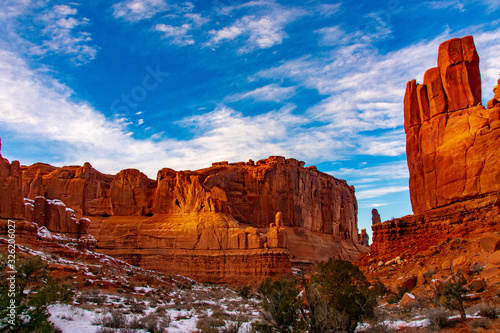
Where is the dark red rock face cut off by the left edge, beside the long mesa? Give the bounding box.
[0,141,24,219]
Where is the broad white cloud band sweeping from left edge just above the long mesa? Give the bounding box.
[0,50,306,178]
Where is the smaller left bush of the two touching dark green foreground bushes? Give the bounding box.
[256,275,303,332]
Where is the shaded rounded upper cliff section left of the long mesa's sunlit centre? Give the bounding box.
[23,163,156,216]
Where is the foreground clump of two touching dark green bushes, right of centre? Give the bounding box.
[252,259,376,333]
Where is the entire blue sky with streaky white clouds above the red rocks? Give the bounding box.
[0,0,500,239]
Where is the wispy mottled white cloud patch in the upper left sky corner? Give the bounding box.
[31,5,98,64]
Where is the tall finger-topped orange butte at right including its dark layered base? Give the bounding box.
[358,36,500,276]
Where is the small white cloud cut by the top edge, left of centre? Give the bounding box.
[113,0,169,22]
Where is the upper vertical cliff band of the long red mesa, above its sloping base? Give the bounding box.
[23,157,358,242]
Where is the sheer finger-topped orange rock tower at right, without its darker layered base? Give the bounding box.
[404,36,500,213]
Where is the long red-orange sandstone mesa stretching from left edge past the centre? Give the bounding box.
[0,137,367,283]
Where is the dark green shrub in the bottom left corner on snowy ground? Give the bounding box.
[0,256,73,332]
